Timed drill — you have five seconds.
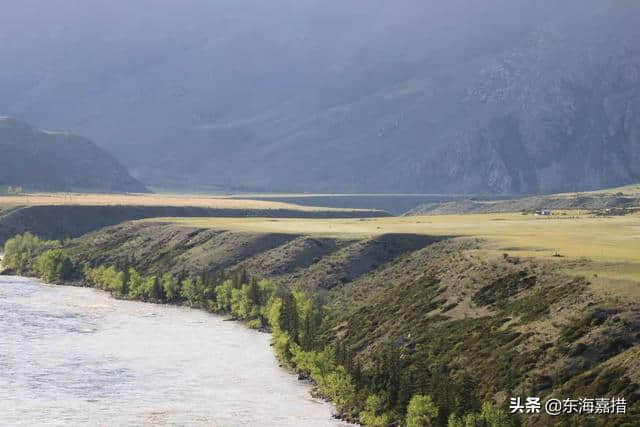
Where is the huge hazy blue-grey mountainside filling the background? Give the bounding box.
[0,0,640,193]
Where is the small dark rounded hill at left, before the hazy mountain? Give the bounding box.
[0,117,147,192]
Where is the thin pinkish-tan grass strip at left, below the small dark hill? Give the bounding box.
[0,193,362,211]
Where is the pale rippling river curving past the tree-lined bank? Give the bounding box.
[0,276,347,426]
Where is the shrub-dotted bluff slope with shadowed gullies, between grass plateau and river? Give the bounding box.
[6,221,640,425]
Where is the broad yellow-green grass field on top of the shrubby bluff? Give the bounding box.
[155,211,640,282]
